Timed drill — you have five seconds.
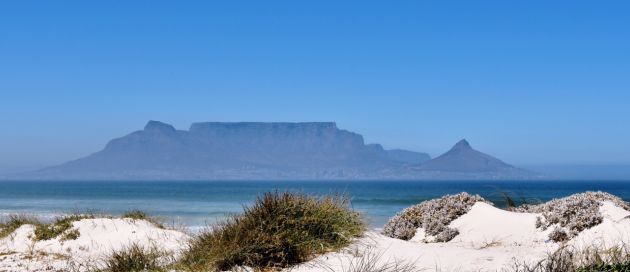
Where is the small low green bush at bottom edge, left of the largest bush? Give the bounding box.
[102,244,167,272]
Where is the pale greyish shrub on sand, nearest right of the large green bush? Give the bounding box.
[383,192,487,242]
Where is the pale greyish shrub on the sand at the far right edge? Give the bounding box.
[514,192,630,242]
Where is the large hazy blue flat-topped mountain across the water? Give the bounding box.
[26,121,430,179]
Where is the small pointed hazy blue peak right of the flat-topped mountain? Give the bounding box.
[413,139,536,179]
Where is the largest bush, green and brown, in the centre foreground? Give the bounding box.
[181,192,365,271]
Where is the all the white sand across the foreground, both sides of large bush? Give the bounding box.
[0,202,630,272]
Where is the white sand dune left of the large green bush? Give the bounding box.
[0,218,189,271]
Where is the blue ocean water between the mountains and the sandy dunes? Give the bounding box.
[0,181,630,229]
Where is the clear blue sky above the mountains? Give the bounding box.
[0,1,630,172]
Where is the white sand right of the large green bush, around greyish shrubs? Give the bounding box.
[291,202,630,271]
